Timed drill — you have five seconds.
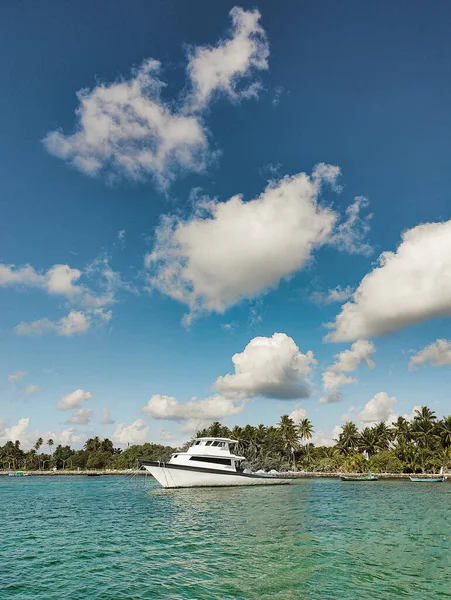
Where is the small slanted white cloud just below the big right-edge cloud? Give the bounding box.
[320,340,376,404]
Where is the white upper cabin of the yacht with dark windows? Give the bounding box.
[169,437,245,472]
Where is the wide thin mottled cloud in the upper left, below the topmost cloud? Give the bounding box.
[43,59,208,187]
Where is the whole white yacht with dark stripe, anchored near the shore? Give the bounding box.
[139,437,292,488]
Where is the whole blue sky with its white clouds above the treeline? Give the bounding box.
[0,0,451,445]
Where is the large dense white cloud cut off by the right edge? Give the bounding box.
[326,220,451,341]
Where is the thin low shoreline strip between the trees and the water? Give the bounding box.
[0,469,451,481]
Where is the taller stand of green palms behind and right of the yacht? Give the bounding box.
[198,406,451,473]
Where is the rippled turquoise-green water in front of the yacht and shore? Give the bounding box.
[0,477,451,600]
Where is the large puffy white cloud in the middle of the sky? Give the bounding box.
[145,164,370,322]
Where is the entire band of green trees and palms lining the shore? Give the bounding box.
[0,406,451,473]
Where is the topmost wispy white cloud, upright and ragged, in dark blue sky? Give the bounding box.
[188,6,269,109]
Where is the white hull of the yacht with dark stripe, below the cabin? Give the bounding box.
[140,460,293,488]
